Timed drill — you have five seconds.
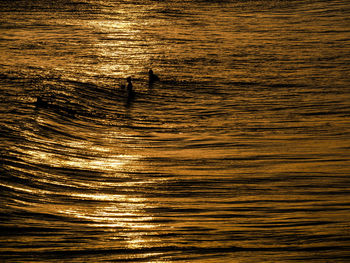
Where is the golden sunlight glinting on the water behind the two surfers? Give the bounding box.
[86,5,156,78]
